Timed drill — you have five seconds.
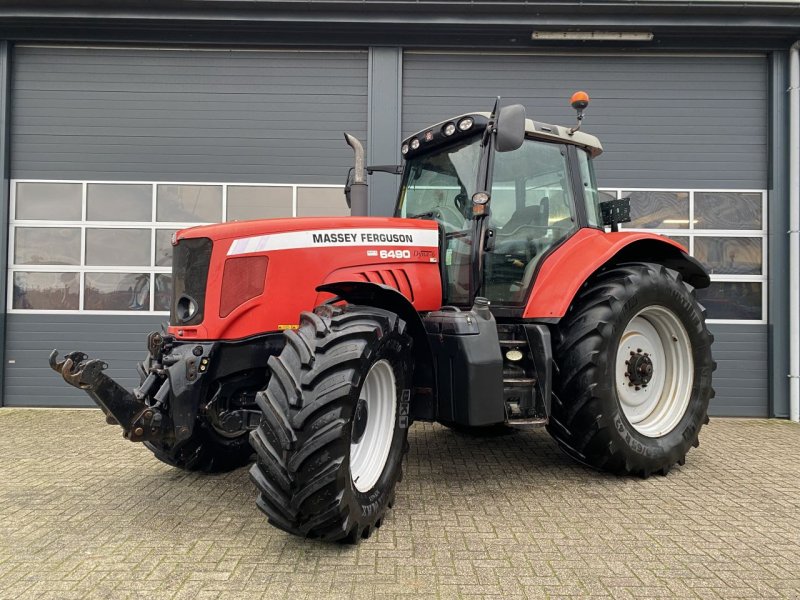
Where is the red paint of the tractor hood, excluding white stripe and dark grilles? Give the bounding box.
[169,217,442,340]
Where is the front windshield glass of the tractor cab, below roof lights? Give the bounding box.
[397,137,480,232]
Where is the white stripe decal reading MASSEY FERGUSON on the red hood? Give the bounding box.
[228,228,439,256]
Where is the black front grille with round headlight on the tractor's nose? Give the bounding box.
[169,238,213,325]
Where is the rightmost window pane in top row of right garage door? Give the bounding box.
[694,192,762,229]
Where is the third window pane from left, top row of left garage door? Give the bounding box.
[156,185,222,223]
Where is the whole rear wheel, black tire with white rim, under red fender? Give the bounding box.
[548,263,715,477]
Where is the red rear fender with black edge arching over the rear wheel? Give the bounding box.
[523,228,710,320]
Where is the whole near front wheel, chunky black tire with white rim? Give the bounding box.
[250,305,413,543]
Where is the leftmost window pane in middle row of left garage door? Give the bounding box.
[14,227,81,265]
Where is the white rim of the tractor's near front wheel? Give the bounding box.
[350,360,397,493]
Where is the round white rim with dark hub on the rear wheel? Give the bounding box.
[614,306,694,438]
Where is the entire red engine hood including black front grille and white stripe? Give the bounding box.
[169,217,442,340]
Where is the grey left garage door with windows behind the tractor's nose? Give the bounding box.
[4,46,368,406]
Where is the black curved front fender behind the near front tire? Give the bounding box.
[317,281,436,421]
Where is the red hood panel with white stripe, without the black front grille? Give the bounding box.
[169,217,442,340]
